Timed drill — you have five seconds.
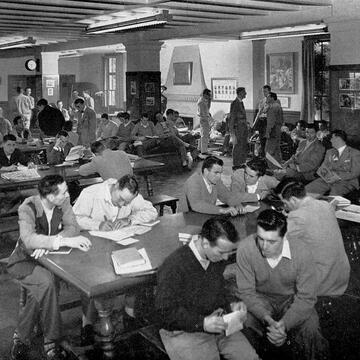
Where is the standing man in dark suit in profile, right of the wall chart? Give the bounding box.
[229,87,248,168]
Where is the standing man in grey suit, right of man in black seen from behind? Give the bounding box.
[74,98,96,146]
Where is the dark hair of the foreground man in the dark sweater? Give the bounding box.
[200,217,239,246]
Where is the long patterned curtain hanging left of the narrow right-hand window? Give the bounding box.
[300,39,315,123]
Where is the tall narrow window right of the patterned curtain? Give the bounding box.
[313,39,330,121]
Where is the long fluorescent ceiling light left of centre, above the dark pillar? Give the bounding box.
[86,10,172,34]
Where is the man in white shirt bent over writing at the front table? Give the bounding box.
[74,175,157,231]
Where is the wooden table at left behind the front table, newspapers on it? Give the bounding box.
[0,159,164,196]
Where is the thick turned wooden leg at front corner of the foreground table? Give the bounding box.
[95,298,115,359]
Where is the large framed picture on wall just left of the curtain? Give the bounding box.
[267,53,295,94]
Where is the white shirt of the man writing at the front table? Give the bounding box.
[73,179,158,230]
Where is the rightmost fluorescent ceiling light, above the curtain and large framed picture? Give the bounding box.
[239,23,327,40]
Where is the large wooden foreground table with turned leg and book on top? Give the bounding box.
[39,213,257,358]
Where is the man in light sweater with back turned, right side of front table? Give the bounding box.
[276,178,350,296]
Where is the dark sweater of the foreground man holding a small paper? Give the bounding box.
[155,246,229,332]
